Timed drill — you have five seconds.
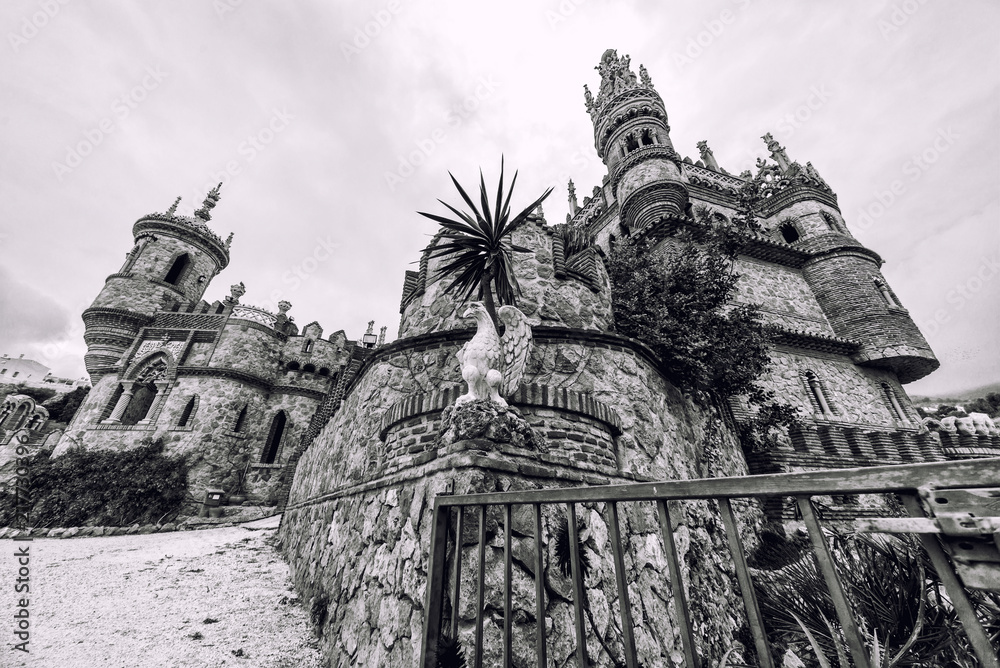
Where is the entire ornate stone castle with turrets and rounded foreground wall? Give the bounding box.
[13,50,1000,665]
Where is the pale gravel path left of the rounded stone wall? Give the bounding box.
[0,517,322,668]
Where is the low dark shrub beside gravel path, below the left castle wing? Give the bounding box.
[0,439,188,527]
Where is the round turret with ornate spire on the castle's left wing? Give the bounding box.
[83,184,229,383]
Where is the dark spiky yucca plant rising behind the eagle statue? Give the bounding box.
[417,158,552,329]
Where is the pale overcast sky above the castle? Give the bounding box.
[0,0,1000,394]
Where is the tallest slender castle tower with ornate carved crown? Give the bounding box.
[584,49,688,230]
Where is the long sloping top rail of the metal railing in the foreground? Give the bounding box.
[441,457,1000,506]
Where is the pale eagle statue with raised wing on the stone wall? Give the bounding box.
[455,302,531,406]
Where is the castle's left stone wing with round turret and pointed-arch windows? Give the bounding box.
[55,187,367,503]
